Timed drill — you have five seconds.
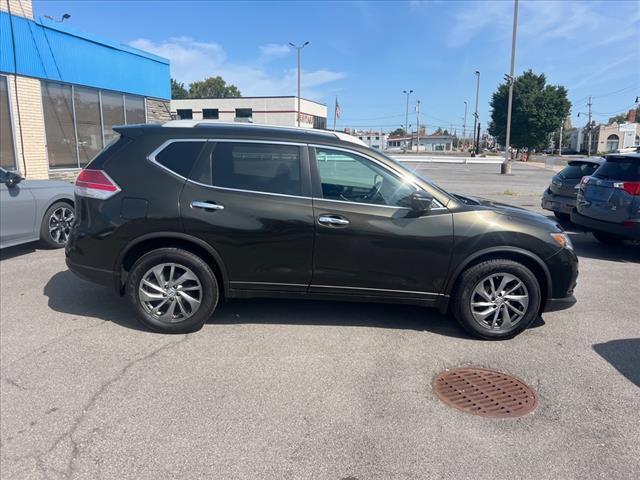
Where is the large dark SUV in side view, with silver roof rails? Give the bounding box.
[66,120,578,339]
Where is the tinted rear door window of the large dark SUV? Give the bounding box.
[191,142,302,195]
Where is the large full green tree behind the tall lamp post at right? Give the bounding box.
[489,70,571,149]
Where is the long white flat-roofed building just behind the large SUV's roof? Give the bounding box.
[171,97,327,129]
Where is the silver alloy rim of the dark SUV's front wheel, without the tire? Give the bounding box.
[470,273,529,331]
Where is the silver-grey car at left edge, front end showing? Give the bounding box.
[0,168,75,248]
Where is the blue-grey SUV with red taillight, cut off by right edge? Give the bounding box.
[571,153,640,243]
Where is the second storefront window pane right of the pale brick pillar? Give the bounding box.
[73,87,102,166]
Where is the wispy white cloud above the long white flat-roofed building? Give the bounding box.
[130,37,345,100]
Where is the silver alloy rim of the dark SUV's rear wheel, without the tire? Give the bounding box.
[138,263,202,323]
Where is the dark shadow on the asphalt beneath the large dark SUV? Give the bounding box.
[43,270,544,338]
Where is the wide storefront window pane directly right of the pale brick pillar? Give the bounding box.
[42,82,78,168]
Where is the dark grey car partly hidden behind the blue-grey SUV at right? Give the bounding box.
[542,158,604,220]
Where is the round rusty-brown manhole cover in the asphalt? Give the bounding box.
[433,368,538,417]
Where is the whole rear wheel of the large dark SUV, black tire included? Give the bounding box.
[127,248,220,333]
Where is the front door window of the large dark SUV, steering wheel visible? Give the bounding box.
[316,148,416,206]
